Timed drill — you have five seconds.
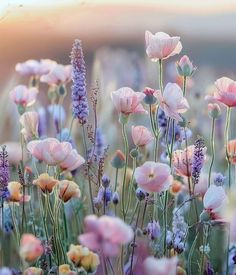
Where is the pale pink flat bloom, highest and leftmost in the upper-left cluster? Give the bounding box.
[15,59,56,76]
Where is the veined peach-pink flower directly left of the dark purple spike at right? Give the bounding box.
[172,145,194,177]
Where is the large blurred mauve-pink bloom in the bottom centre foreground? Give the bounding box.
[79,215,134,256]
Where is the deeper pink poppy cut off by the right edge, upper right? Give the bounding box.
[214,77,236,107]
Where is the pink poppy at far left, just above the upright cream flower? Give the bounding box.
[10,85,38,108]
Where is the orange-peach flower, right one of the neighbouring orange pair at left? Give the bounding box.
[58,180,81,202]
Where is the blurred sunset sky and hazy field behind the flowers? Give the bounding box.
[0,0,236,149]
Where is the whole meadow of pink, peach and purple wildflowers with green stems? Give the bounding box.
[0,31,236,275]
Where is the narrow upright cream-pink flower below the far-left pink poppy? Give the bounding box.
[19,112,39,141]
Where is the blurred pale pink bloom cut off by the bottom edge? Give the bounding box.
[143,256,178,275]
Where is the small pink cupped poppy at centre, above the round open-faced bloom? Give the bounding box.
[132,126,153,146]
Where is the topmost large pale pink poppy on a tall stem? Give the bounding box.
[145,31,182,61]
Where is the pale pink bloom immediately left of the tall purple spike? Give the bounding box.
[40,64,72,85]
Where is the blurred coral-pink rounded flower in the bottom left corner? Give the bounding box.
[20,233,44,262]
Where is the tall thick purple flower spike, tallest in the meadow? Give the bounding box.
[71,39,89,125]
